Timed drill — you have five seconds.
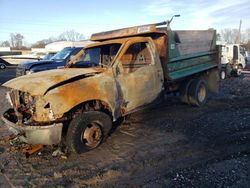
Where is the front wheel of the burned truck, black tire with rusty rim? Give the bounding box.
[66,111,112,154]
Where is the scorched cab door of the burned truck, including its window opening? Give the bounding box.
[116,41,163,112]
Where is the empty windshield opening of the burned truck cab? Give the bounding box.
[71,44,121,68]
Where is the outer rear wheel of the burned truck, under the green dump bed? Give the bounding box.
[188,79,208,106]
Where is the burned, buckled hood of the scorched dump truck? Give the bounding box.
[3,68,103,96]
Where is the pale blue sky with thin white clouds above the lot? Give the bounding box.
[0,0,250,43]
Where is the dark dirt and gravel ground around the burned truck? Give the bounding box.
[0,68,250,187]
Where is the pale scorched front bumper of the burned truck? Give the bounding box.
[2,116,63,145]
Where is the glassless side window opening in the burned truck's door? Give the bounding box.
[120,42,152,73]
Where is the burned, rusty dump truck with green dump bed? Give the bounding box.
[2,21,219,153]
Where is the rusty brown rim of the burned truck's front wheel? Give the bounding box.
[81,123,102,148]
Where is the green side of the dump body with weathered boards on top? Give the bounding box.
[165,29,218,81]
